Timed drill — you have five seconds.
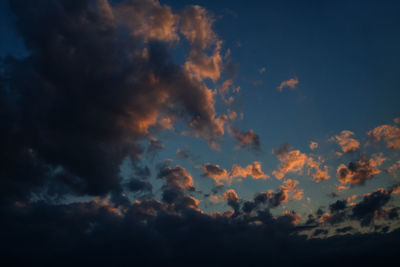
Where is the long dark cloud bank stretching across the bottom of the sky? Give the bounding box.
[0,201,400,266]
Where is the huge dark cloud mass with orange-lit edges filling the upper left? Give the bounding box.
[0,0,227,202]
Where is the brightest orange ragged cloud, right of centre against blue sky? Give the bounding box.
[272,144,330,183]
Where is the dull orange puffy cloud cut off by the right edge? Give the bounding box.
[368,125,400,149]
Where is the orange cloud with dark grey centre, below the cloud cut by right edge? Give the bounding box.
[336,154,385,186]
